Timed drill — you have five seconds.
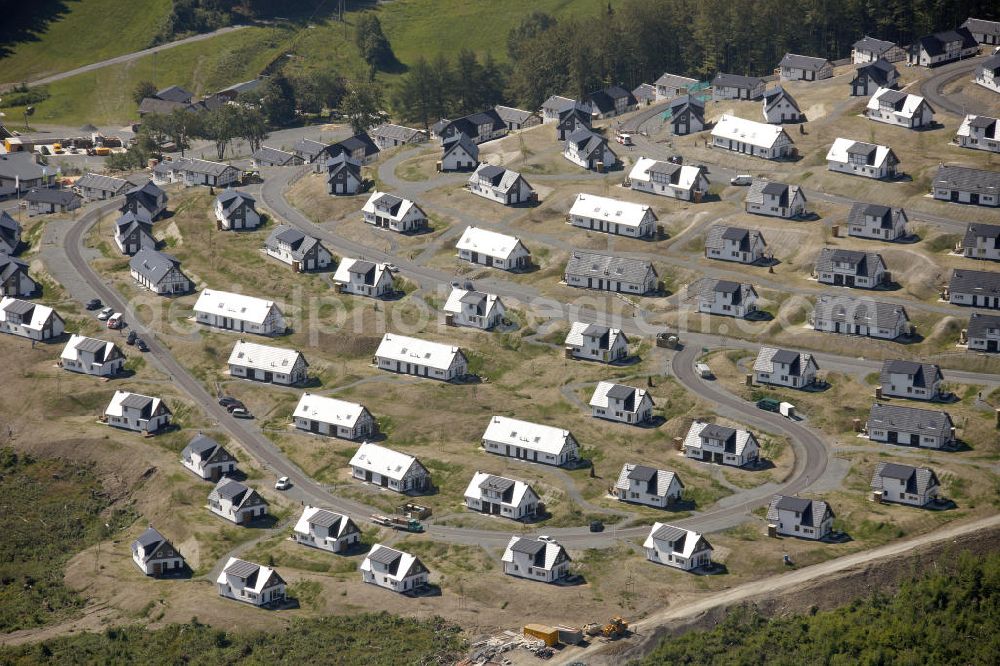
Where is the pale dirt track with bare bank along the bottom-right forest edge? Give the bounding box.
[550,515,1000,666]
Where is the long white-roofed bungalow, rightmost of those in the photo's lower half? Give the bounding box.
[483,416,580,466]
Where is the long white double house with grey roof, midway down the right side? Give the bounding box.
[812,294,910,340]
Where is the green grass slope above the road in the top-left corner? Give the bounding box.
[0,0,172,83]
